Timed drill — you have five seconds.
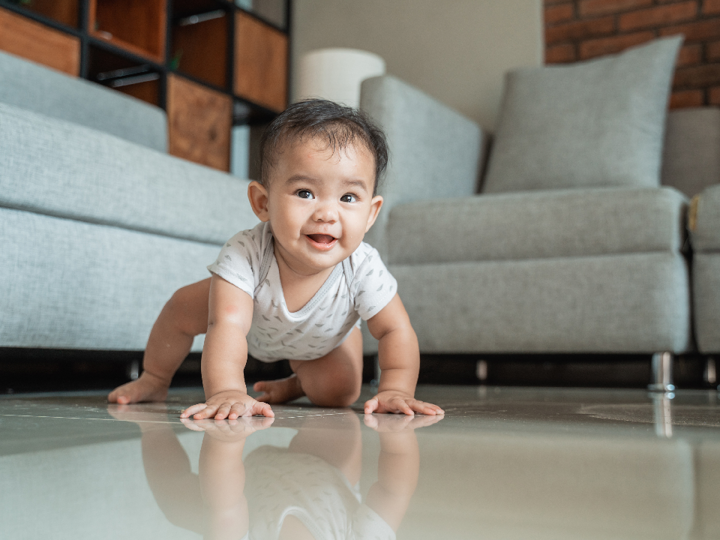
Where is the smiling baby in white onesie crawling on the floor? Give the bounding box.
[108,100,443,420]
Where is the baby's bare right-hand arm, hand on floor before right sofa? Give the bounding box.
[365,294,444,416]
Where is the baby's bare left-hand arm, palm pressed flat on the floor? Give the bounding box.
[181,275,274,420]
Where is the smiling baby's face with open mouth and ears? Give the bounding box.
[251,140,382,275]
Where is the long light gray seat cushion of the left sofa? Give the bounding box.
[0,104,258,244]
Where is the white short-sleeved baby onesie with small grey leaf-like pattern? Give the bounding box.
[208,223,397,362]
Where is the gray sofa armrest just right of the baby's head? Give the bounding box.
[360,76,484,256]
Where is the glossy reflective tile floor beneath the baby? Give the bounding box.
[0,387,720,540]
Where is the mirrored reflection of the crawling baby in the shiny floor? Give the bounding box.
[111,404,442,540]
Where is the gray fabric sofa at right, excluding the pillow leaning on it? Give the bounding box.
[361,77,720,389]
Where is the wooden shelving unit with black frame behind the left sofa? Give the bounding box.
[0,0,291,171]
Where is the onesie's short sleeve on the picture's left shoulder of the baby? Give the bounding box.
[208,223,269,298]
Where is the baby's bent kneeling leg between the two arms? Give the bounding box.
[253,328,362,407]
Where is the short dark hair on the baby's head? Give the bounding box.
[260,99,388,195]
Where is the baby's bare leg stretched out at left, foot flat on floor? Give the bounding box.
[108,278,210,403]
